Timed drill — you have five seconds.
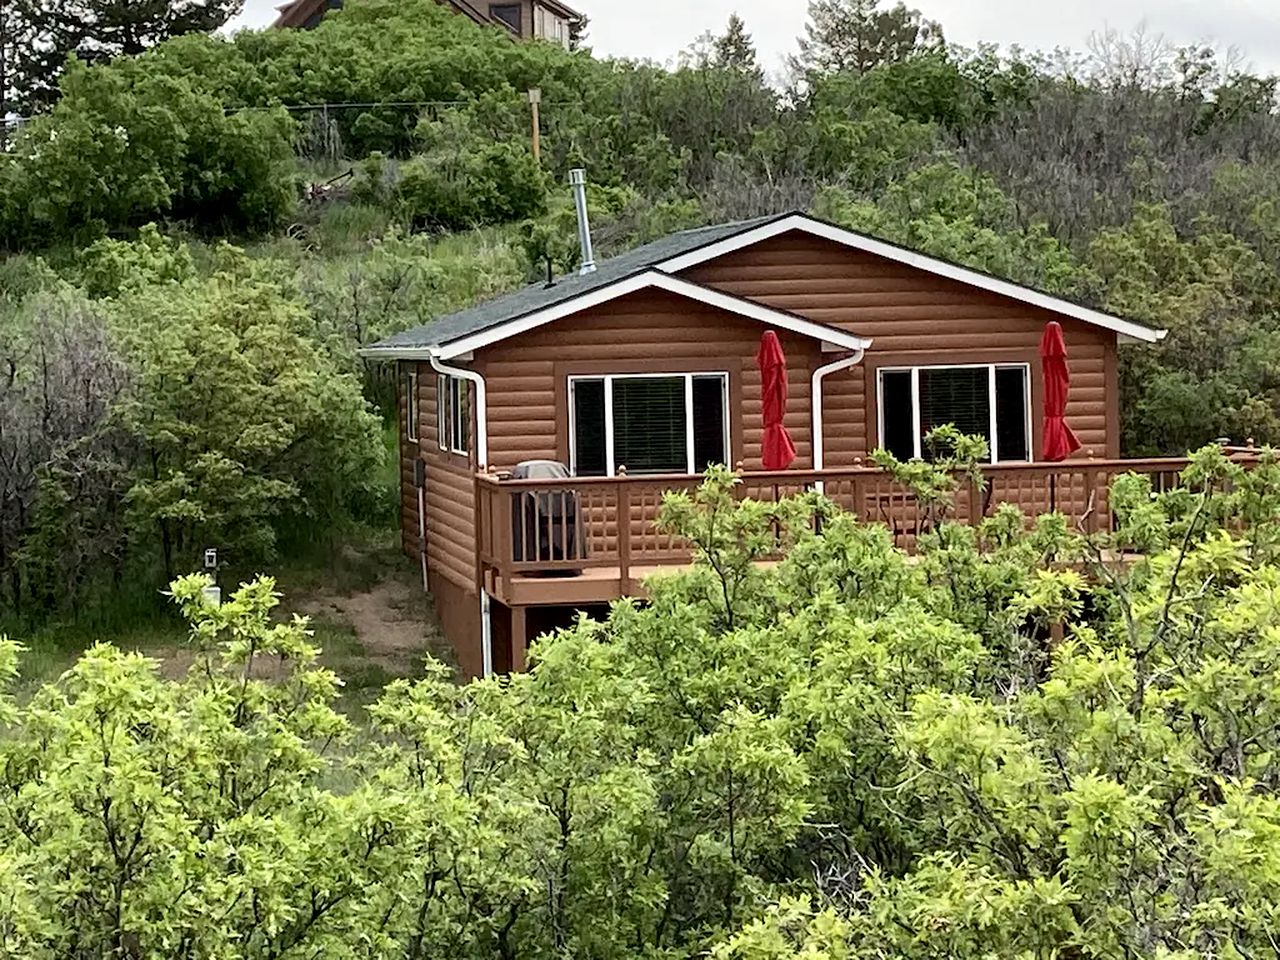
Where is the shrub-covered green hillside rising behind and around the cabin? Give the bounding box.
[0,0,1280,609]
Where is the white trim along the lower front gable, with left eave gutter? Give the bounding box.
[361,270,872,361]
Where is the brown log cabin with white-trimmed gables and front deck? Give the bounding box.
[365,214,1180,676]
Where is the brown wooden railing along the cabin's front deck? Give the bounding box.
[476,460,1239,584]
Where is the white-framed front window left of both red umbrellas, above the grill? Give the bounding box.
[568,371,730,476]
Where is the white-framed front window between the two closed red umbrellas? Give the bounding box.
[877,364,1032,463]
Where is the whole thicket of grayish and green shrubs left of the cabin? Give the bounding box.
[0,227,385,611]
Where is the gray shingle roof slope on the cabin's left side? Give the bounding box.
[360,214,787,352]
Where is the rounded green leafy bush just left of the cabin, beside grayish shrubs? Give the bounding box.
[111,248,383,573]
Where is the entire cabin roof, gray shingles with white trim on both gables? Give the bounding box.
[362,214,1166,360]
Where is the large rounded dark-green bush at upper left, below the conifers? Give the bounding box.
[0,61,296,248]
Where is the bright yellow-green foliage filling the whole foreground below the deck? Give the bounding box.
[0,450,1280,960]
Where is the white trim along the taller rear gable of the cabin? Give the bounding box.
[657,214,1169,343]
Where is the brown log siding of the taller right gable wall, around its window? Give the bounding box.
[684,233,1120,467]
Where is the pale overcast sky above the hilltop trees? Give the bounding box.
[227,0,1280,72]
